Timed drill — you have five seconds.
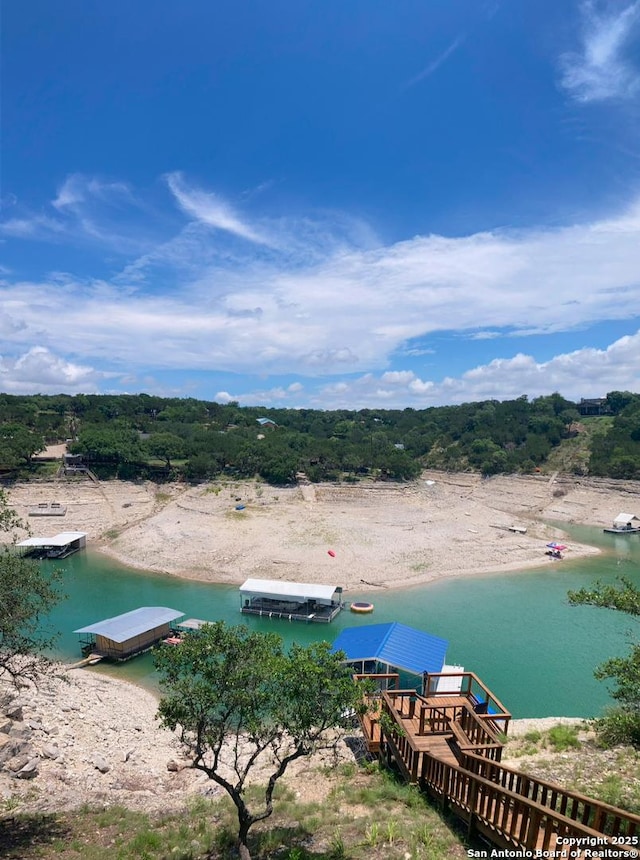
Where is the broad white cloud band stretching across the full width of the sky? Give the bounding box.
[0,193,640,382]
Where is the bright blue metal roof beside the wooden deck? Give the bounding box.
[333,621,449,675]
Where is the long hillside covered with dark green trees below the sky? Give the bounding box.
[0,391,640,484]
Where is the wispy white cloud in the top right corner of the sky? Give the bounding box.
[560,0,640,102]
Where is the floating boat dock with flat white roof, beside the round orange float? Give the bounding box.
[240,579,344,624]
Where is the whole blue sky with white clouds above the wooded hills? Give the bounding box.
[0,0,640,409]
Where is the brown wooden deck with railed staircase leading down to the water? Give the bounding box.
[360,673,640,860]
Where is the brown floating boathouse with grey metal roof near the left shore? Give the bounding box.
[73,606,184,660]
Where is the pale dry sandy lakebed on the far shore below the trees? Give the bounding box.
[0,464,640,591]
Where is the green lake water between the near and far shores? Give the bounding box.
[43,526,640,717]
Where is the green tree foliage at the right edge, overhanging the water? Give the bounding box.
[568,577,640,746]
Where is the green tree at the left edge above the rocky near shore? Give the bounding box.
[0,490,61,683]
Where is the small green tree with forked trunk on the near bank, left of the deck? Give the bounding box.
[155,622,362,860]
